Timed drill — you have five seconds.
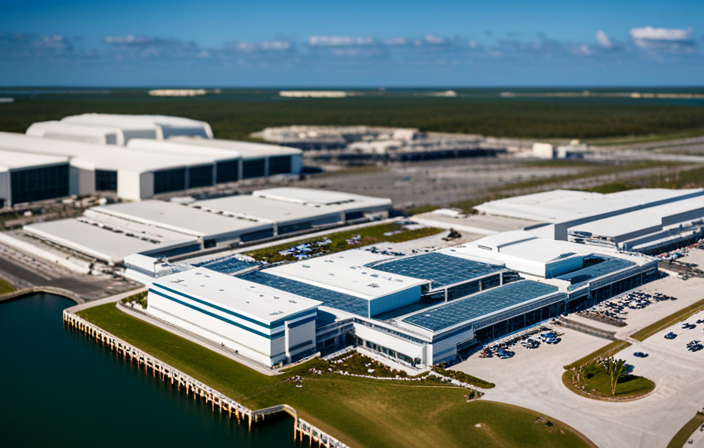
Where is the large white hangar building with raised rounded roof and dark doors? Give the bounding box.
[0,114,303,205]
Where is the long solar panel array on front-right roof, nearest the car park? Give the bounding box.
[403,280,558,331]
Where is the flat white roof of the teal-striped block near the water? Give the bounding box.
[154,268,322,323]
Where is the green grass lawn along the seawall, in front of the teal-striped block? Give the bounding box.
[80,304,593,448]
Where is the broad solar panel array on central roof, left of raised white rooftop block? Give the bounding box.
[366,252,504,288]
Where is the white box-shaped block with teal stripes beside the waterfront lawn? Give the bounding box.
[147,268,320,366]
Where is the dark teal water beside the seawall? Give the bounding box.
[0,294,296,448]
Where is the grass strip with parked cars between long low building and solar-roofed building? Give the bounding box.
[246,222,444,263]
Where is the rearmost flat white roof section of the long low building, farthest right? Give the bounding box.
[252,187,391,208]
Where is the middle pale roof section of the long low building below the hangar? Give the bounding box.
[90,200,272,237]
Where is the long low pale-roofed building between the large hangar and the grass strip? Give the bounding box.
[24,188,391,264]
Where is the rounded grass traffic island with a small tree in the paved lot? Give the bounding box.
[562,341,655,400]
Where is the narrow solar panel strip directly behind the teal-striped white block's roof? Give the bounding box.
[237,271,368,317]
